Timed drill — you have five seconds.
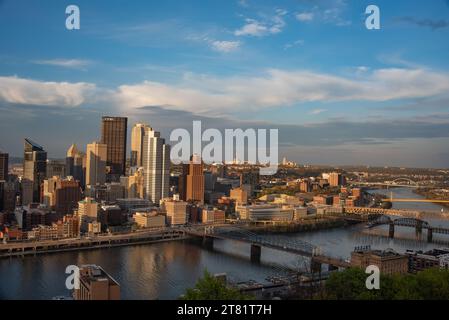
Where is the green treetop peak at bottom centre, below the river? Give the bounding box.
[181,270,251,300]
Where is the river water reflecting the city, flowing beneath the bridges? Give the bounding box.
[0,188,449,299]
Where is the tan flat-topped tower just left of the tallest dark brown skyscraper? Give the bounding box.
[86,142,107,186]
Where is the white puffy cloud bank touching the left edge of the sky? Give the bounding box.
[0,77,96,107]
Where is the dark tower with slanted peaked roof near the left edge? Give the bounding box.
[23,139,47,202]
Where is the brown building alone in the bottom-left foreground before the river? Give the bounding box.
[73,265,120,300]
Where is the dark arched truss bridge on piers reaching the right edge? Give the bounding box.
[368,215,449,242]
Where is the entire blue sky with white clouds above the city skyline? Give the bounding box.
[0,0,449,168]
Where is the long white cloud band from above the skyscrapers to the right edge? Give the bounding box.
[115,69,449,114]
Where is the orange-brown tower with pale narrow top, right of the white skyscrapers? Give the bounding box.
[182,155,204,204]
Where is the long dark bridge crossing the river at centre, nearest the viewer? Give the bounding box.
[184,226,350,271]
